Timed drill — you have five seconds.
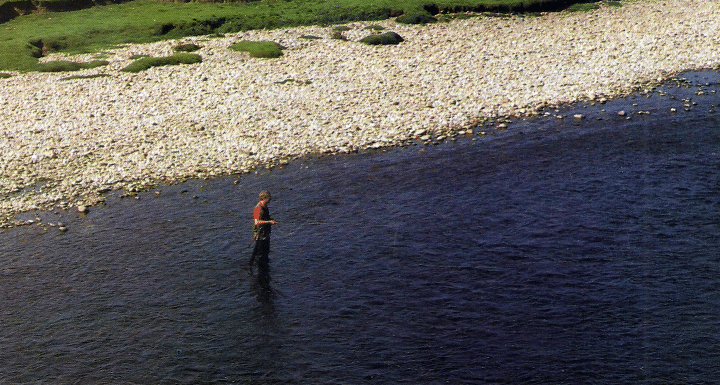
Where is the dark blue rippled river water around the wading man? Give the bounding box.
[0,72,720,384]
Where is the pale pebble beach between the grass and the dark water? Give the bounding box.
[0,0,720,227]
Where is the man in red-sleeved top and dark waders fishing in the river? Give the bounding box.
[250,190,277,287]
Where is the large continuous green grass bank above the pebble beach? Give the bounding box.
[0,0,608,71]
